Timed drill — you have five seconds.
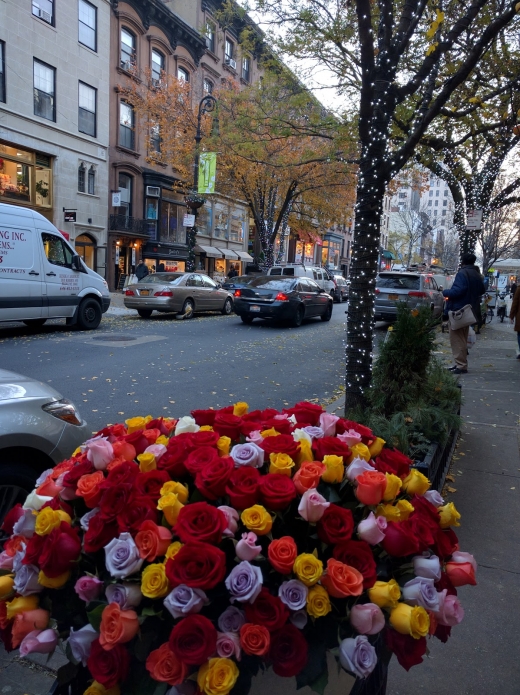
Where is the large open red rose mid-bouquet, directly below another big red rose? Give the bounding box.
[166,541,226,591]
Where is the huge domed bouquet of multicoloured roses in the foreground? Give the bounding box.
[0,402,476,695]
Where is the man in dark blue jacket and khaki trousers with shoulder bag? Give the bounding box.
[443,253,488,374]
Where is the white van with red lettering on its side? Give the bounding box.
[0,203,110,330]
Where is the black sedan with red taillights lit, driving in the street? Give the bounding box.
[234,275,332,326]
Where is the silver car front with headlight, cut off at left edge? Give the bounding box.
[0,369,91,524]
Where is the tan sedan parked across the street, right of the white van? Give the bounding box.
[124,273,233,319]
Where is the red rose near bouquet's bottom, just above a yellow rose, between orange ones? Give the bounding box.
[169,614,217,666]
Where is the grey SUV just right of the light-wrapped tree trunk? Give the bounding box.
[375,271,444,321]
